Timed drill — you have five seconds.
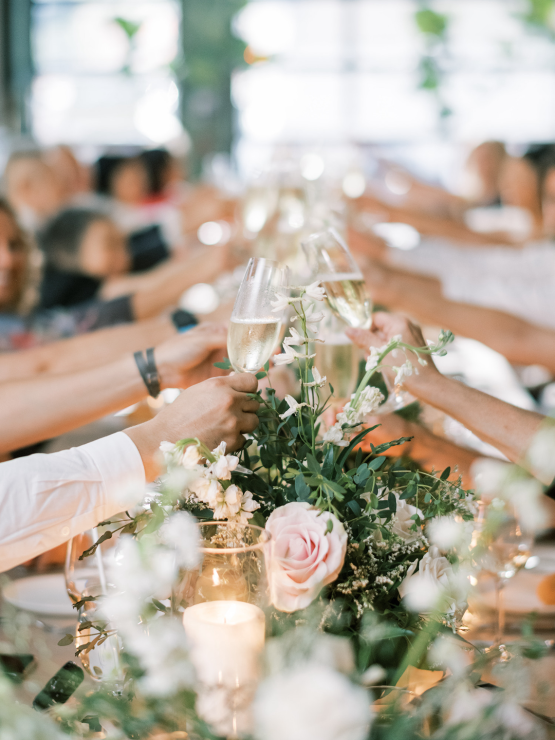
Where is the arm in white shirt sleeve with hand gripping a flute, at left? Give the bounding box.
[0,375,258,571]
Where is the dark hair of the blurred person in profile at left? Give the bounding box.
[38,208,108,272]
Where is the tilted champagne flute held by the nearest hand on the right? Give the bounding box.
[303,227,372,329]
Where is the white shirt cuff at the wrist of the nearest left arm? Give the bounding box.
[80,432,146,511]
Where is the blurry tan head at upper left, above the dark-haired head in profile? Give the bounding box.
[4,151,69,231]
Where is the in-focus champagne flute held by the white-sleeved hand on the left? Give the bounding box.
[227,257,289,373]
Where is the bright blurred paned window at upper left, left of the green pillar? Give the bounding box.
[31,0,182,152]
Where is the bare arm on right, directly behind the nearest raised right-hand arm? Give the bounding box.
[363,262,555,373]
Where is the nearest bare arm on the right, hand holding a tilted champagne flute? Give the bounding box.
[346,313,544,472]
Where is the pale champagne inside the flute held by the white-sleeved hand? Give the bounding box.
[227,318,281,373]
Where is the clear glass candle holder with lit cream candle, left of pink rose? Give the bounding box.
[172,522,270,737]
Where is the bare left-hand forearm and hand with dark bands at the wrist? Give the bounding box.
[0,324,227,453]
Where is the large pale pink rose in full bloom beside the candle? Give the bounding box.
[266,501,347,612]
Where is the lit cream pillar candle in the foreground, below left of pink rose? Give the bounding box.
[183,601,265,737]
